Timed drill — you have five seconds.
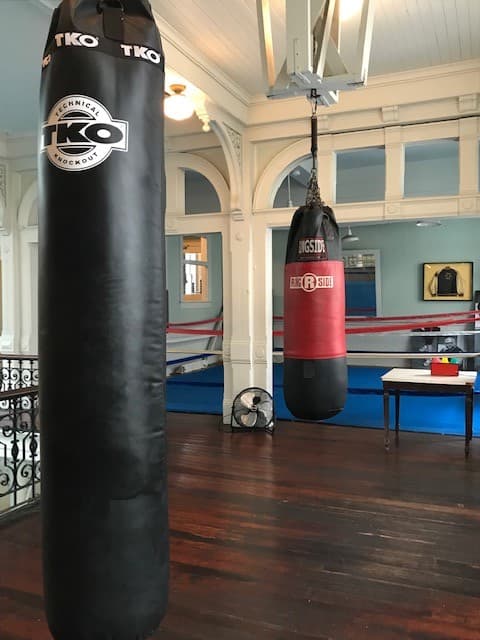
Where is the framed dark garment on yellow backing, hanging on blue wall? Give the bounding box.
[423,262,473,302]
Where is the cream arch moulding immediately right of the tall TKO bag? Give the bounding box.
[165,153,230,213]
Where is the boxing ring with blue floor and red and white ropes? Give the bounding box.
[167,311,480,436]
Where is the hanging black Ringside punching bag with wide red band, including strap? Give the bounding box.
[284,112,347,420]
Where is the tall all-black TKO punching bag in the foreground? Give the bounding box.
[39,0,168,640]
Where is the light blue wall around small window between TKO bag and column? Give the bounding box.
[166,233,223,322]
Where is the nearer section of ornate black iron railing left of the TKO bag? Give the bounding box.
[0,386,40,518]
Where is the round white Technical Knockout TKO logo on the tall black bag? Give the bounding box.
[40,95,128,171]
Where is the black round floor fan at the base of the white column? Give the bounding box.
[230,387,275,433]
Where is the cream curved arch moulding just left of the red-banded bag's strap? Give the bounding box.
[253,138,310,211]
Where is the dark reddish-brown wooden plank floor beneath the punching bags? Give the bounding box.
[0,414,480,640]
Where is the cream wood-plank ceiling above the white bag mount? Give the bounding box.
[151,0,480,95]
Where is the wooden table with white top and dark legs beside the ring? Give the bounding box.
[382,369,477,456]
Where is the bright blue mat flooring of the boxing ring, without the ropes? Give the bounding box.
[167,365,480,435]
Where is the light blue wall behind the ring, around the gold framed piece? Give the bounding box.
[272,219,480,315]
